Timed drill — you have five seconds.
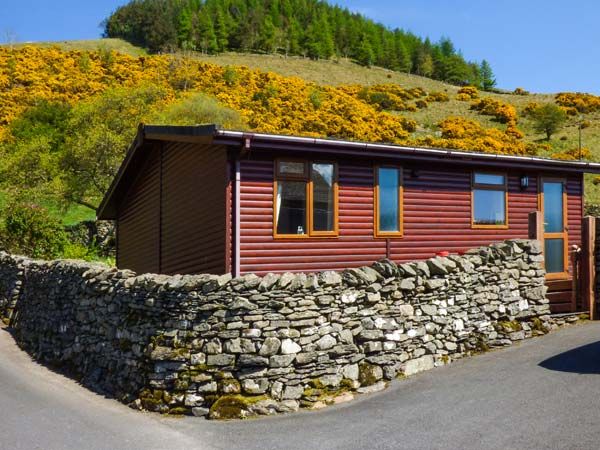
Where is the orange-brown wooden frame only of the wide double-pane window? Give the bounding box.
[273,158,339,239]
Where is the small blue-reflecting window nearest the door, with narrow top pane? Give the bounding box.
[471,172,508,228]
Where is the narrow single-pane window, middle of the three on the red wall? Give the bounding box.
[375,167,403,237]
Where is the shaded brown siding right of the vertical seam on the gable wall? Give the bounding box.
[160,142,227,274]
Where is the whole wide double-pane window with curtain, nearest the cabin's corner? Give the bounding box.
[273,160,338,238]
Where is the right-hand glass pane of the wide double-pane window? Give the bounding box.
[311,163,335,231]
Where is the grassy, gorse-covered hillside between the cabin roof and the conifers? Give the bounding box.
[0,39,600,215]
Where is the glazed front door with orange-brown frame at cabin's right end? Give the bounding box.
[540,178,569,279]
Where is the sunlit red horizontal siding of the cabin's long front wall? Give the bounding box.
[240,159,581,273]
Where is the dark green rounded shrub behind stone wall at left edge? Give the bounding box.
[0,202,68,259]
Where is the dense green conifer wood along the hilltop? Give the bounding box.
[104,0,496,89]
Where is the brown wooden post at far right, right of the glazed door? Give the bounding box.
[580,216,596,320]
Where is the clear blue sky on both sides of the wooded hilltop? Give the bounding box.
[0,0,600,93]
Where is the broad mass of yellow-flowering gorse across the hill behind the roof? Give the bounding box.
[0,46,531,154]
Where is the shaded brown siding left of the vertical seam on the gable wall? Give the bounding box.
[117,144,161,273]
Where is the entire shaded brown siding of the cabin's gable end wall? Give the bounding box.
[118,142,227,274]
